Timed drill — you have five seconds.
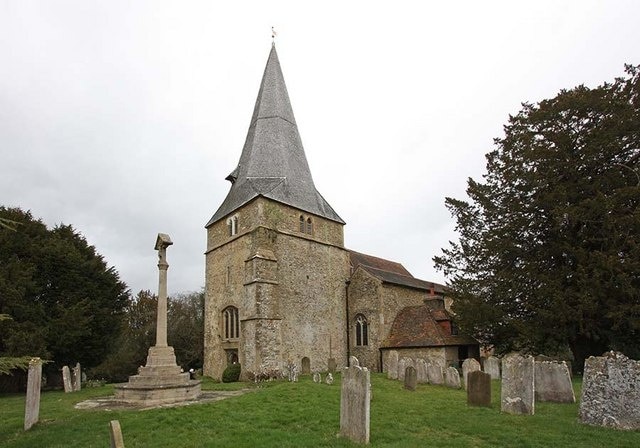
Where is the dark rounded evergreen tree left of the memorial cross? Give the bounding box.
[0,207,129,378]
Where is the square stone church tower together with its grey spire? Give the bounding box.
[204,46,350,379]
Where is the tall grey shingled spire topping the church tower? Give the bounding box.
[206,45,344,227]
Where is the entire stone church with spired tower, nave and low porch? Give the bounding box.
[203,45,479,379]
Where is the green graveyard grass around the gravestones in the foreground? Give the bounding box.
[0,374,640,448]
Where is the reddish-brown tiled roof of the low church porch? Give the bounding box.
[382,305,478,348]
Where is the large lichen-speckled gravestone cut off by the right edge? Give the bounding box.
[580,352,640,430]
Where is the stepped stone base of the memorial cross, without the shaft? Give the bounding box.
[114,347,201,406]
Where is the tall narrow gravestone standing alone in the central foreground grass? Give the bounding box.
[340,358,371,443]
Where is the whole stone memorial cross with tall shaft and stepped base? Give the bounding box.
[114,233,201,406]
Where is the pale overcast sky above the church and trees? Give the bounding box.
[0,0,640,293]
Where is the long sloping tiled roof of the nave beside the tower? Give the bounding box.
[349,250,446,294]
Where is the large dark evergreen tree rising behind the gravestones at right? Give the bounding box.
[434,66,640,366]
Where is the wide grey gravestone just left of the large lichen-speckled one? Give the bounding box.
[534,361,576,403]
